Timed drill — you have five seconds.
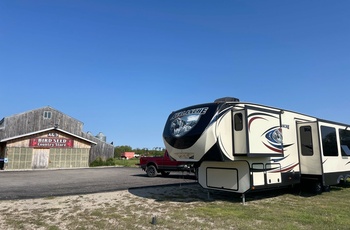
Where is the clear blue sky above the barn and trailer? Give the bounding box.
[0,0,350,148]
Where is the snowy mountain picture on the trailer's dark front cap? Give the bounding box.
[170,107,208,137]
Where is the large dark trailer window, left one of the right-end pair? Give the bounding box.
[321,126,338,156]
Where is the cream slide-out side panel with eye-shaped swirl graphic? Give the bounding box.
[247,107,283,156]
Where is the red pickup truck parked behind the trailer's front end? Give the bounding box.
[138,151,194,177]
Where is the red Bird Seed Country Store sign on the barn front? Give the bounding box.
[29,137,74,148]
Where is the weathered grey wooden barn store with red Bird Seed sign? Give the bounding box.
[0,106,114,170]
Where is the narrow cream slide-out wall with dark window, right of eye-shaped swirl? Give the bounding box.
[297,122,322,176]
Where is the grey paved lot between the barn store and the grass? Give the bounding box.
[0,167,195,200]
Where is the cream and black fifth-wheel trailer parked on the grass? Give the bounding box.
[163,97,350,194]
